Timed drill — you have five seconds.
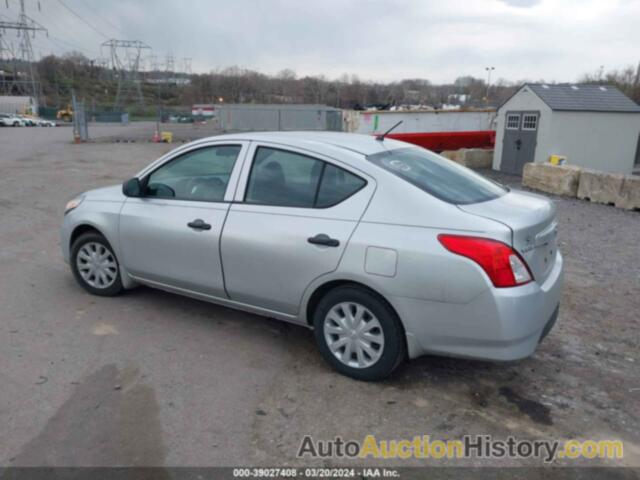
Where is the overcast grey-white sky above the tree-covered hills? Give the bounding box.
[13,0,640,83]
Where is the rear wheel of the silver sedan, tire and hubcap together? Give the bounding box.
[313,286,405,380]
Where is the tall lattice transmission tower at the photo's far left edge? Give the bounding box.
[0,0,48,99]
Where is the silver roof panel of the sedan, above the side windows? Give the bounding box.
[201,131,412,155]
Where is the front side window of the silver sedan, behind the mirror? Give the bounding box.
[145,145,242,202]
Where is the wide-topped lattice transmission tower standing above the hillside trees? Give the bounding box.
[102,39,151,107]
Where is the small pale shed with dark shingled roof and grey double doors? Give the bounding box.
[493,84,640,174]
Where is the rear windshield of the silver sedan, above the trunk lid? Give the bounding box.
[367,148,507,205]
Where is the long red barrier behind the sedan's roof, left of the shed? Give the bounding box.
[387,130,496,152]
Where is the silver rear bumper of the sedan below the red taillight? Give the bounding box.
[390,252,563,361]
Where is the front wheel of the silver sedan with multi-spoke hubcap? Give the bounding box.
[70,233,123,297]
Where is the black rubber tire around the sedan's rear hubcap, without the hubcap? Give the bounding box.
[313,285,406,381]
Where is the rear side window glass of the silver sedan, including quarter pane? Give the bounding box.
[245,147,366,208]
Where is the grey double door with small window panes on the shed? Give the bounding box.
[500,112,540,175]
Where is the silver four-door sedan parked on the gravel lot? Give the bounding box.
[61,132,563,380]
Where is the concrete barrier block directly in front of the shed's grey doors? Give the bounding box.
[522,163,581,197]
